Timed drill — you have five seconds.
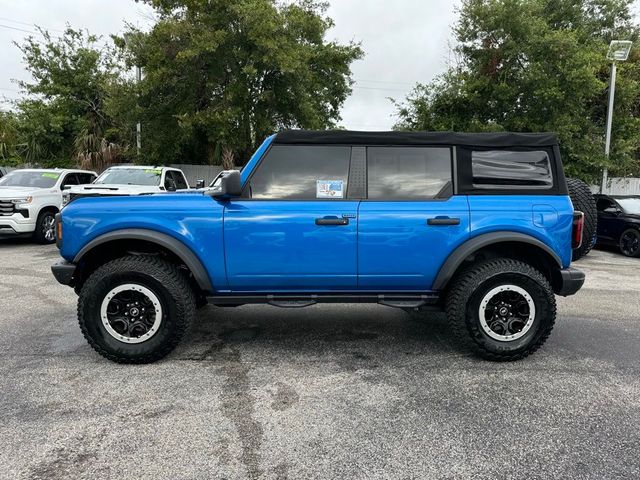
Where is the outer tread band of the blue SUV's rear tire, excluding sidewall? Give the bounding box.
[445,258,557,362]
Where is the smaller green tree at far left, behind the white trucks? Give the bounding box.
[17,28,127,167]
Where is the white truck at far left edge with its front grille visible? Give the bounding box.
[0,168,96,243]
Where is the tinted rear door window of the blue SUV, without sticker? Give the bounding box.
[367,147,452,200]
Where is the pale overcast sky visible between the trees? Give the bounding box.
[0,0,640,130]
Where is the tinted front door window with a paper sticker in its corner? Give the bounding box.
[248,145,351,200]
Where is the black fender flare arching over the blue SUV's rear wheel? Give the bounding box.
[432,231,562,290]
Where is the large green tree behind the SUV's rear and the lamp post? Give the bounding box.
[397,0,640,180]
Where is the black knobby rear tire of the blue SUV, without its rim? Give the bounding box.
[445,258,556,361]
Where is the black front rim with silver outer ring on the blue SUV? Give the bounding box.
[100,283,162,343]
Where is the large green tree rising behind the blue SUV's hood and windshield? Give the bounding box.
[112,0,362,164]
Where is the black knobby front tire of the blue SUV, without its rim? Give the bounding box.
[78,255,196,363]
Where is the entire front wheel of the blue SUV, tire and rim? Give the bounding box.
[78,255,195,363]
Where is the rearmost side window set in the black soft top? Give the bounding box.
[471,150,553,189]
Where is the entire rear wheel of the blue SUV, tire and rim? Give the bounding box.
[446,259,556,361]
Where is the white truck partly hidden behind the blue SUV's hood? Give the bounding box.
[62,165,189,206]
